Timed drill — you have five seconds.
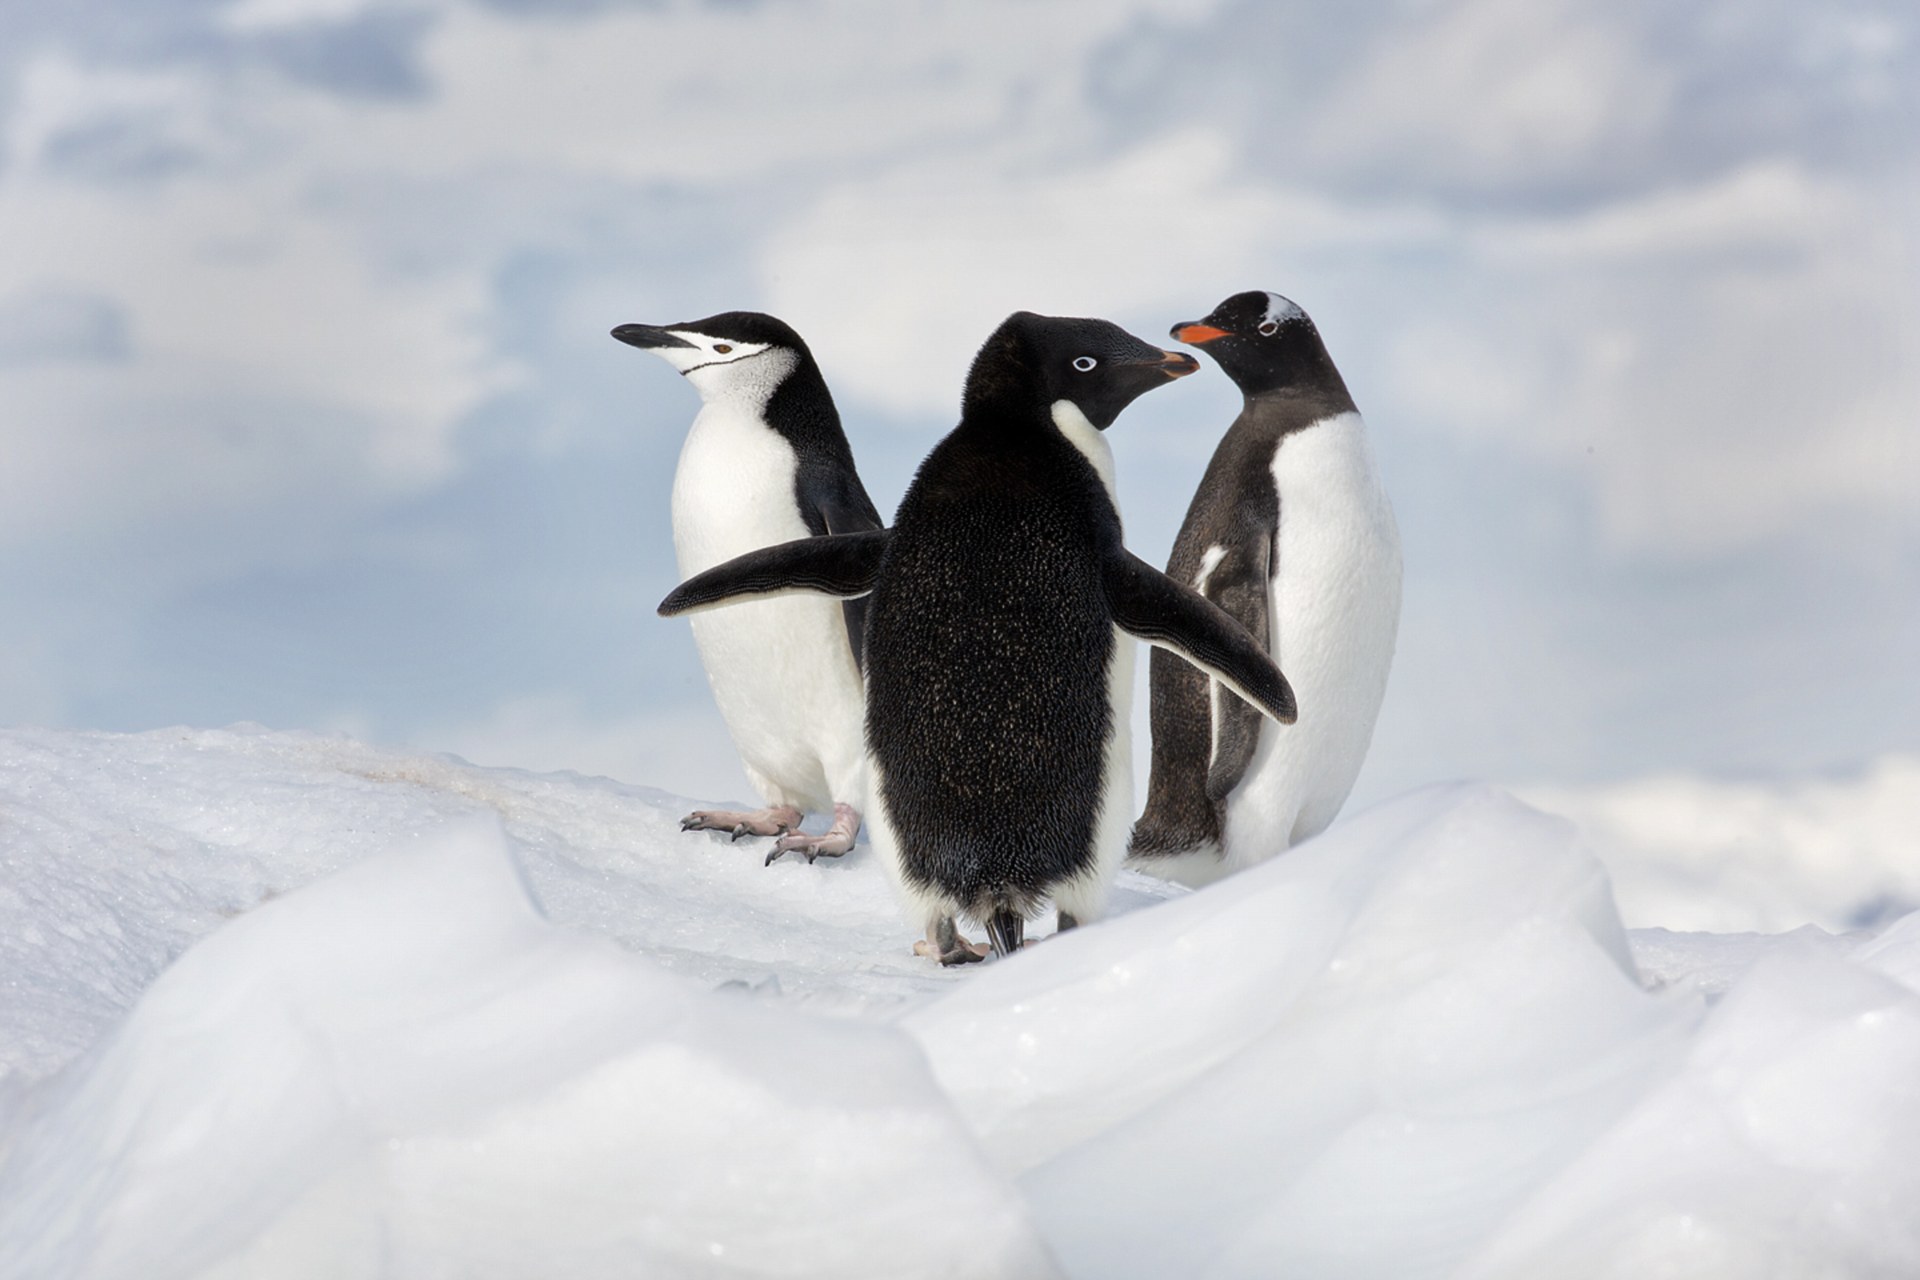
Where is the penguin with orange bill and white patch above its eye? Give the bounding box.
[1129,292,1400,885]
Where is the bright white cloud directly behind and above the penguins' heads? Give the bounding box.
[762,132,1436,415]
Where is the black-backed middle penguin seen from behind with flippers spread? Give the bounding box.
[660,311,1292,963]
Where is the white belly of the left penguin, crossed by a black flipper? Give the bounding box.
[672,403,866,810]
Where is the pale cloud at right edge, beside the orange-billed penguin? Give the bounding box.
[1390,161,1920,558]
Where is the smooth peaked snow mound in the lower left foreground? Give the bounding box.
[0,821,1050,1280]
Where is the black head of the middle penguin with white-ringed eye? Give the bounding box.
[964,311,1200,432]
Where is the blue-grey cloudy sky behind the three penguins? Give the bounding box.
[0,0,1920,800]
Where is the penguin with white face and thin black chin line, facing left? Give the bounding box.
[612,311,879,864]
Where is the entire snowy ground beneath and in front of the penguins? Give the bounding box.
[0,729,1920,1280]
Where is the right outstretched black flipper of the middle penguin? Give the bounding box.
[1104,549,1298,723]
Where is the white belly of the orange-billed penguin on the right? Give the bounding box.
[1221,413,1400,873]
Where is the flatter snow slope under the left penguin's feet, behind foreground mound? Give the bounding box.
[0,725,1185,1080]
